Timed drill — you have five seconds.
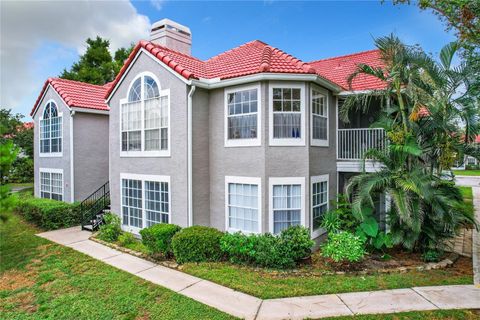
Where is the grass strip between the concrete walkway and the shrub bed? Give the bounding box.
[182,262,472,299]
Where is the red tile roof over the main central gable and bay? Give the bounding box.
[106,40,315,97]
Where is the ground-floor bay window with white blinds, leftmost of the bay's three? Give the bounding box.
[228,183,259,232]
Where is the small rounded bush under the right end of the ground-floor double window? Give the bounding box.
[140,223,182,257]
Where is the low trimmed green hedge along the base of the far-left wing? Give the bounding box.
[14,196,82,230]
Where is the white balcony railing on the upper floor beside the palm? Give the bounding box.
[337,128,387,160]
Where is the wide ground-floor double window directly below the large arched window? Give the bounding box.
[121,174,171,229]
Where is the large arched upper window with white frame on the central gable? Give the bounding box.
[121,74,170,155]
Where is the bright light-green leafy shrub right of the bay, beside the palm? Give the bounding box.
[322,231,365,262]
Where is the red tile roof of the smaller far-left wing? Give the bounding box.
[30,78,111,116]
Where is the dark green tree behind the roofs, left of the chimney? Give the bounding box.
[60,36,134,85]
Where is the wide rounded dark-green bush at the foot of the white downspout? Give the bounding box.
[172,226,223,263]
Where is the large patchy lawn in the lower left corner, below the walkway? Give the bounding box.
[0,210,233,319]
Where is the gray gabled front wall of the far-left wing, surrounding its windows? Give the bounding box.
[33,87,72,202]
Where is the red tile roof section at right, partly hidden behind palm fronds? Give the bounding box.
[309,50,385,91]
